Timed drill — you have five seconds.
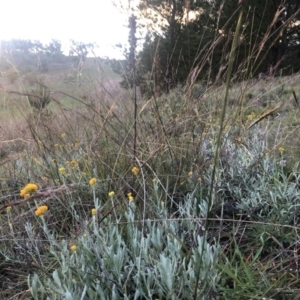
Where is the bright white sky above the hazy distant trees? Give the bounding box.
[0,0,129,58]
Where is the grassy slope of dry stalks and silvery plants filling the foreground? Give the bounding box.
[0,53,300,299]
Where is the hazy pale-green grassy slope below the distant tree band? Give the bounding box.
[0,57,120,120]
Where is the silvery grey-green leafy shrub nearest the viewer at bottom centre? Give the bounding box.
[28,197,220,299]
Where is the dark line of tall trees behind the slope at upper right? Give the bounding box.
[117,0,300,93]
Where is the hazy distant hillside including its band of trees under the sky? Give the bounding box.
[0,52,121,117]
